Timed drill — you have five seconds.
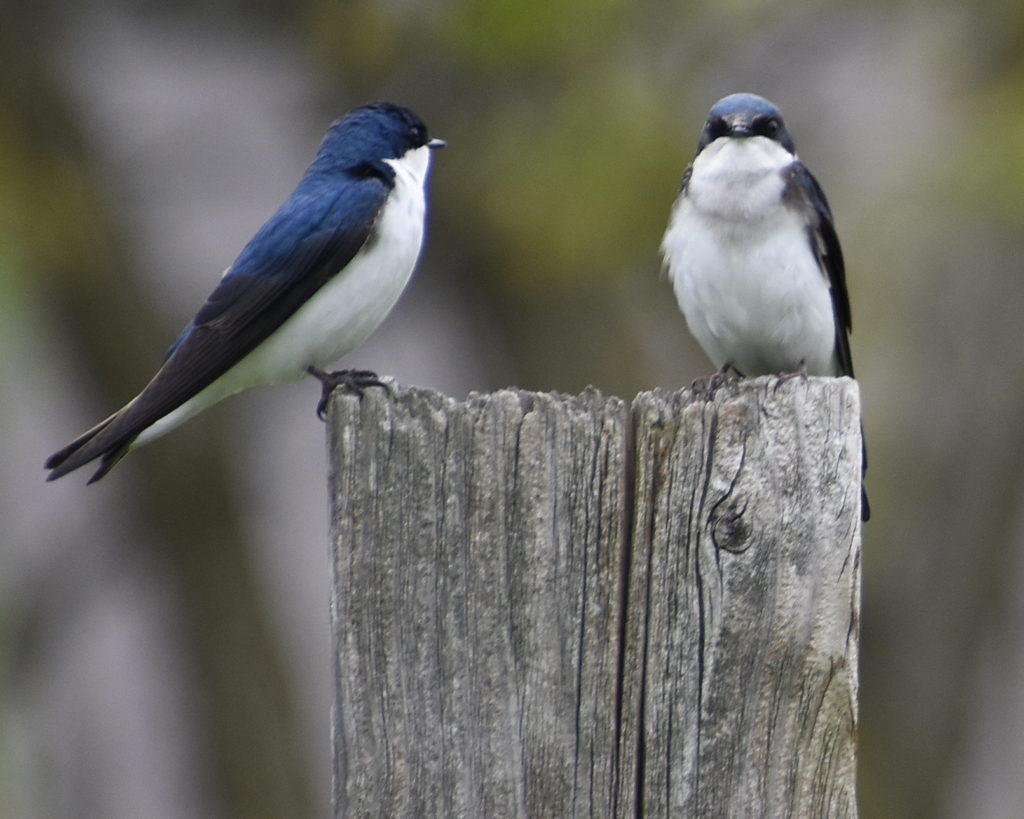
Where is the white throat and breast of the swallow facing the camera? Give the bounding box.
[662,137,839,376]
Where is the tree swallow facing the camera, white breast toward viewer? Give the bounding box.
[662,93,869,520]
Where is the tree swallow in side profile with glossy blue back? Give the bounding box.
[46,102,444,483]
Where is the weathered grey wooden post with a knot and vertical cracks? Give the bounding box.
[330,378,860,817]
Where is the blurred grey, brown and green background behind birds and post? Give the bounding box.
[0,0,1024,819]
